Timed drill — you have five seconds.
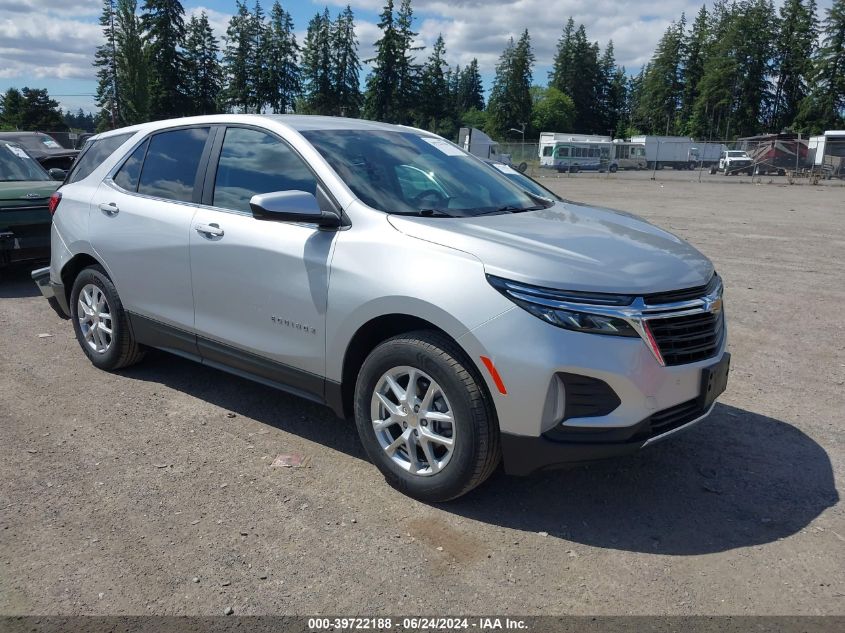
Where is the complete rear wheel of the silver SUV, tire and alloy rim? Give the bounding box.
[70,266,144,371]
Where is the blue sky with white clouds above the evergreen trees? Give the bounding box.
[0,0,830,110]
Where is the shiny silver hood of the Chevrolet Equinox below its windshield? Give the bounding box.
[389,202,713,294]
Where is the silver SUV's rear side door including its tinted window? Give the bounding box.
[90,126,212,330]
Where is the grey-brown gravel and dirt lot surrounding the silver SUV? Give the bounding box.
[0,174,845,615]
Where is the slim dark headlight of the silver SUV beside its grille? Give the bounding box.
[487,276,640,337]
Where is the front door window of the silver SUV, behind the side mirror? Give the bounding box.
[211,128,317,211]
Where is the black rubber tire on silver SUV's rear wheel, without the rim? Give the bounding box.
[70,266,145,371]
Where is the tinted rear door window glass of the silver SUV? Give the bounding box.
[138,127,208,202]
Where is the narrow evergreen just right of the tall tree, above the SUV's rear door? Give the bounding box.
[185,11,223,114]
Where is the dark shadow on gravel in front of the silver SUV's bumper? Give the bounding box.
[440,404,839,555]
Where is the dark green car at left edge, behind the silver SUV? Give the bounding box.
[0,141,65,268]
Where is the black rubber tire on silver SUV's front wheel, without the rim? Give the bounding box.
[355,330,501,503]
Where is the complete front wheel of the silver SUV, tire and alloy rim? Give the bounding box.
[355,331,500,502]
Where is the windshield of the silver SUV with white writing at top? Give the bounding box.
[302,130,543,217]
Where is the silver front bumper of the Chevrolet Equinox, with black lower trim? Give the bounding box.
[459,308,729,474]
